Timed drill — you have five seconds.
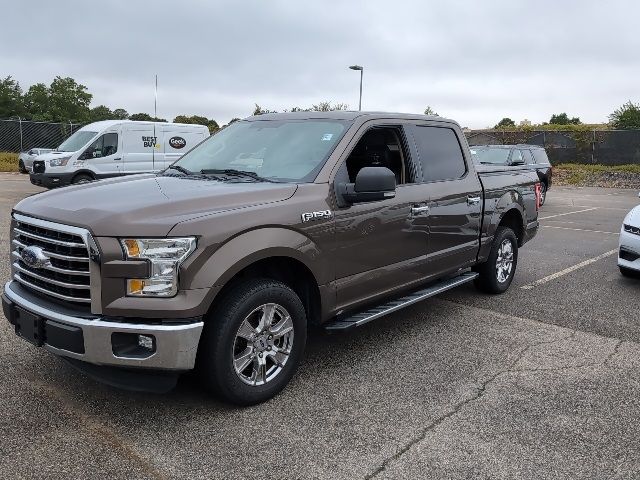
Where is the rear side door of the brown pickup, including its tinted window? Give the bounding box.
[410,123,483,275]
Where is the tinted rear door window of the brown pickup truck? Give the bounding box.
[411,125,467,182]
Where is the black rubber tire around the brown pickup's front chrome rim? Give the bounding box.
[196,279,307,406]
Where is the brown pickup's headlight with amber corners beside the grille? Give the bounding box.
[120,237,196,297]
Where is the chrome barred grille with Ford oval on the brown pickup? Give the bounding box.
[11,214,91,303]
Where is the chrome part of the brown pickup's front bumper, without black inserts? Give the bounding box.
[4,281,204,370]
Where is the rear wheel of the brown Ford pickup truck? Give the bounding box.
[474,227,518,293]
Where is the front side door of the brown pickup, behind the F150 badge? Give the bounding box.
[331,122,429,308]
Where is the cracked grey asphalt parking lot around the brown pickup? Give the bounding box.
[0,174,640,479]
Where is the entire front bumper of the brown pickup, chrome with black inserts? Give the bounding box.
[2,281,204,371]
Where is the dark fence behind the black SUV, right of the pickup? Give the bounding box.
[466,130,640,165]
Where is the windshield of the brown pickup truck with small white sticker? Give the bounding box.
[174,119,351,182]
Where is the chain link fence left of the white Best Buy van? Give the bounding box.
[0,117,82,153]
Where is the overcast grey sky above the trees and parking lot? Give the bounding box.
[0,0,640,128]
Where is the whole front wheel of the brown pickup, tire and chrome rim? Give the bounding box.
[196,279,307,406]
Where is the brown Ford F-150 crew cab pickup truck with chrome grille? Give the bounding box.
[2,112,540,405]
